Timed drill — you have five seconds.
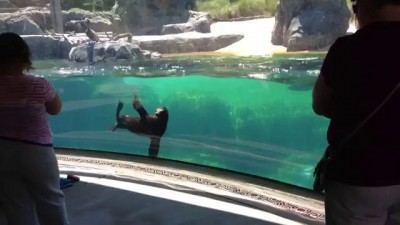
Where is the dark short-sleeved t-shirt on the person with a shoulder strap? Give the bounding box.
[321,22,400,186]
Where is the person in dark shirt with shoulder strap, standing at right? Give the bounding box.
[313,0,400,225]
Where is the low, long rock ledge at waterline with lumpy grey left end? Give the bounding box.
[67,32,244,62]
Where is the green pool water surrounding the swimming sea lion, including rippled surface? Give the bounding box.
[36,56,328,188]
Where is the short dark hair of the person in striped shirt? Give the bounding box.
[0,32,33,70]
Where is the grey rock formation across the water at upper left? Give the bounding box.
[0,0,244,59]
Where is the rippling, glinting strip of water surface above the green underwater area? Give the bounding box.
[36,55,323,83]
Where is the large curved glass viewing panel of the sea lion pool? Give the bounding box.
[0,0,354,188]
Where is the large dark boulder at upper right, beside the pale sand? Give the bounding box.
[271,0,351,51]
